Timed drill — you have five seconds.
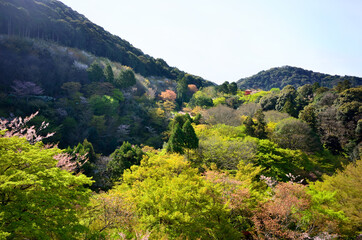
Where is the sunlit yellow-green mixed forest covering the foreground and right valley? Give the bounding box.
[0,79,362,239]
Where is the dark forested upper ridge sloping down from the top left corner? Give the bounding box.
[0,0,212,86]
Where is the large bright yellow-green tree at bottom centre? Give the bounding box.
[112,154,240,239]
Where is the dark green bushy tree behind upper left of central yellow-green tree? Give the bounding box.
[107,142,144,181]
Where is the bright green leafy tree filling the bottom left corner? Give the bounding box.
[0,134,92,239]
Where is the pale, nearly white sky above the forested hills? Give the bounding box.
[61,0,362,84]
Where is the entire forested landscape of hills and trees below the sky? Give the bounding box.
[0,0,362,240]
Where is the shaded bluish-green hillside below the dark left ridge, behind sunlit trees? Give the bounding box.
[0,35,195,153]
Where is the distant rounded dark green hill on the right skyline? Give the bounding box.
[237,66,362,90]
